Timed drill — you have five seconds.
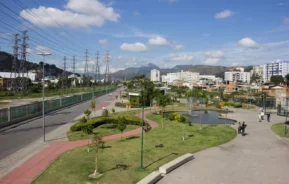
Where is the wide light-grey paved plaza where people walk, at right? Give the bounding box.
[158,109,289,184]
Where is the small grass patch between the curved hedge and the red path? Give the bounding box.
[67,124,140,141]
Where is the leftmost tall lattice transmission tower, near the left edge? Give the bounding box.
[10,34,20,94]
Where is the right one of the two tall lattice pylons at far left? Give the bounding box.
[19,31,28,92]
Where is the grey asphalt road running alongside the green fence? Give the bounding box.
[0,92,115,160]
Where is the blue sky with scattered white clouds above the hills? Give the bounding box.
[0,0,289,72]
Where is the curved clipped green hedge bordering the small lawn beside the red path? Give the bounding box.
[70,116,141,132]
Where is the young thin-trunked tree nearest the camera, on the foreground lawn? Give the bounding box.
[89,134,104,178]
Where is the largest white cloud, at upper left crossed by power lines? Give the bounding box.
[20,0,120,28]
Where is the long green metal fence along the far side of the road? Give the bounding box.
[0,87,116,123]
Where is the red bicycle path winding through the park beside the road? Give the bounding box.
[0,102,158,184]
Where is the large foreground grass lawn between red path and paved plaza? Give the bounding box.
[33,114,237,184]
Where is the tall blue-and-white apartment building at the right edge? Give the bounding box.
[263,60,289,82]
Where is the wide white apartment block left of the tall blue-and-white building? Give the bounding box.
[225,68,251,83]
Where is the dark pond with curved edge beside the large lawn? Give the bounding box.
[181,111,235,124]
